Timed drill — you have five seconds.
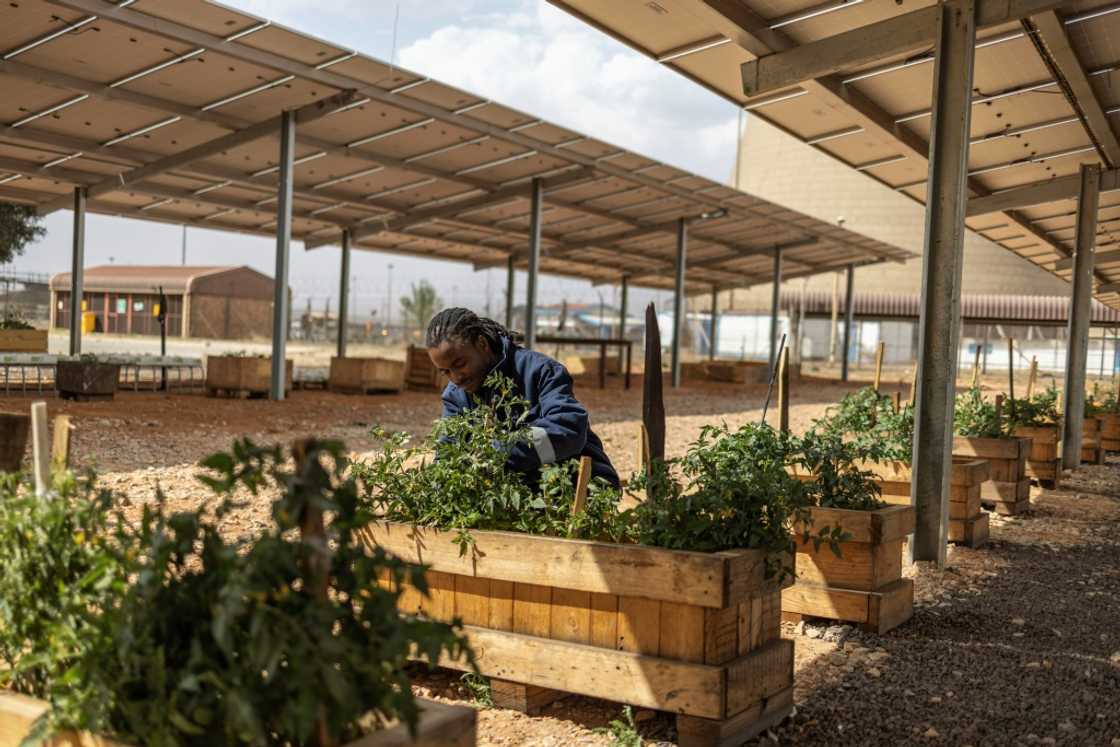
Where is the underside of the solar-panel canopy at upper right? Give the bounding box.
[550,0,1120,308]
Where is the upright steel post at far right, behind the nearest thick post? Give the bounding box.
[1062,164,1100,469]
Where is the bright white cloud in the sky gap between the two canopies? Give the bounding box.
[400,0,736,181]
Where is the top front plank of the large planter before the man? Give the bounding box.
[363,522,739,607]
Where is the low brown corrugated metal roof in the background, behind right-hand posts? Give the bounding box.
[754,290,1120,325]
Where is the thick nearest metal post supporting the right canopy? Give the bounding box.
[911,0,977,568]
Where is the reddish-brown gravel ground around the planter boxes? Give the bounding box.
[0,373,1120,747]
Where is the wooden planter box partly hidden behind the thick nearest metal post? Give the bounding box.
[861,457,990,548]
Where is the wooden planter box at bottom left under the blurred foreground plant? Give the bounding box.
[0,691,477,747]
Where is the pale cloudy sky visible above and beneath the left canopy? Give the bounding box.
[15,0,737,318]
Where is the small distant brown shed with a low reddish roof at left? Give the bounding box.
[50,264,274,339]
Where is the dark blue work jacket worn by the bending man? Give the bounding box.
[444,337,618,487]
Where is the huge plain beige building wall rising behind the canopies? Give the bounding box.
[716,115,1070,309]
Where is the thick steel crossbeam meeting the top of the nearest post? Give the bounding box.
[741,0,1066,96]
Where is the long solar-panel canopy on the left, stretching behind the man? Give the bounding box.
[0,0,912,292]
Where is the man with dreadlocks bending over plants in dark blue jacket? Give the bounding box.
[426,308,618,487]
